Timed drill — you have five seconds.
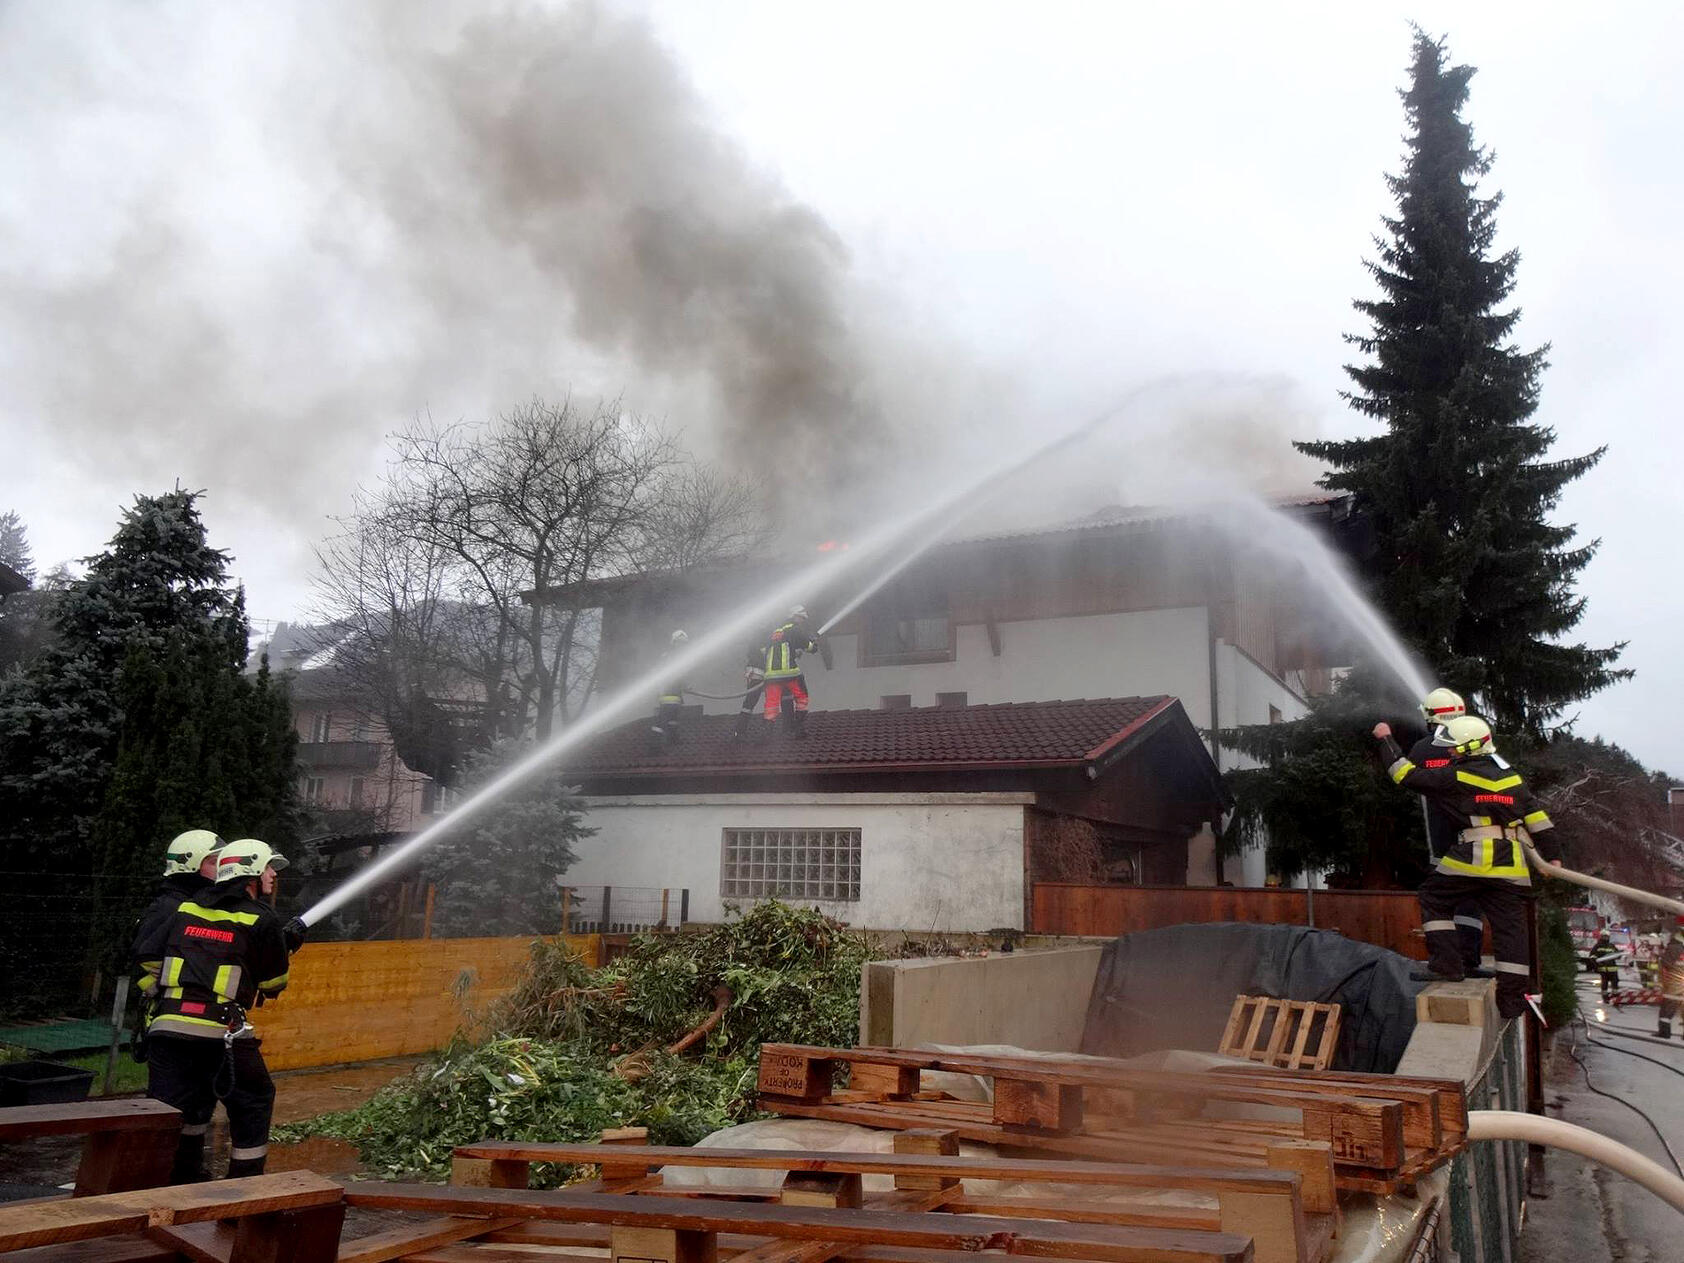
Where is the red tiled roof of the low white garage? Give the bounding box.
[562,695,1177,778]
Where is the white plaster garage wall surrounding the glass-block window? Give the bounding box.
[566,793,1034,931]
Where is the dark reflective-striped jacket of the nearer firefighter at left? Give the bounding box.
[135,879,288,1039]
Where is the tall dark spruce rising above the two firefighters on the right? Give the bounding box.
[1295,29,1630,736]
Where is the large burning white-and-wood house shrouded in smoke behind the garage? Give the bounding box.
[534,497,1361,886]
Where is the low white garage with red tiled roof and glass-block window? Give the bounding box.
[564,695,1224,930]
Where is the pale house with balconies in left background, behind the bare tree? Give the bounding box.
[253,623,448,835]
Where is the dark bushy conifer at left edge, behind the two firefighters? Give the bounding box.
[0,490,295,1007]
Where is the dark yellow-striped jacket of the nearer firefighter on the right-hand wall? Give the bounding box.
[1381,738,1558,886]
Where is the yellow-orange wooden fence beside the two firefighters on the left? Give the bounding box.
[251,935,603,1069]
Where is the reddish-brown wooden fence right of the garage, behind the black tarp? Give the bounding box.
[1031,881,1426,960]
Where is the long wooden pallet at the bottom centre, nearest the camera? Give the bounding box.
[338,1132,1337,1263]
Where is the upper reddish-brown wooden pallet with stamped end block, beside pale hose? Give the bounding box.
[759,1044,1467,1209]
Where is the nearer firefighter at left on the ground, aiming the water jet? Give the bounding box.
[135,839,303,1184]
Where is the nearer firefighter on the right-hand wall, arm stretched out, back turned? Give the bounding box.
[1374,716,1558,1017]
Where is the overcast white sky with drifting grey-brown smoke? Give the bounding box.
[0,0,1684,775]
